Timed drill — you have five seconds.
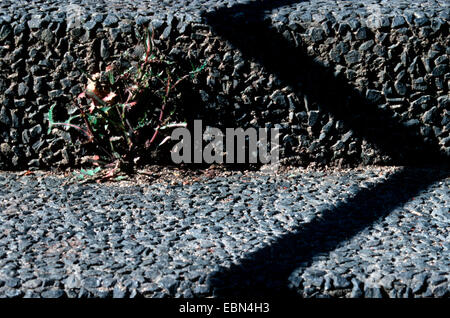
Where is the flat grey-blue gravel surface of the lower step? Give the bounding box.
[0,167,450,297]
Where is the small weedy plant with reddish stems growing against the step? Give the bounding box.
[48,29,206,180]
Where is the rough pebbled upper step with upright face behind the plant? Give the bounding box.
[0,0,450,169]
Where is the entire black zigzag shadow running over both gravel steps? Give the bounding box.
[204,0,449,297]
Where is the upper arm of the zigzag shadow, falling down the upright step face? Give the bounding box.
[204,0,448,165]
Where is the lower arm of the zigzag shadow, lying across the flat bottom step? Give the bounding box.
[210,168,450,297]
